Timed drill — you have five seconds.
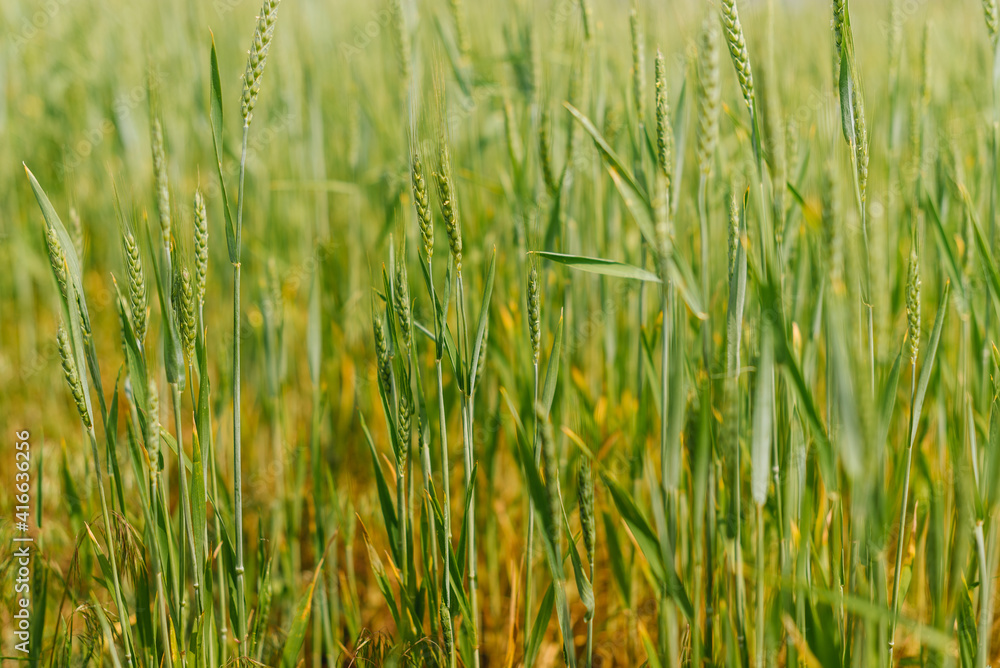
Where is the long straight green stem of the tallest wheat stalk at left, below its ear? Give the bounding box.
[233,123,250,658]
